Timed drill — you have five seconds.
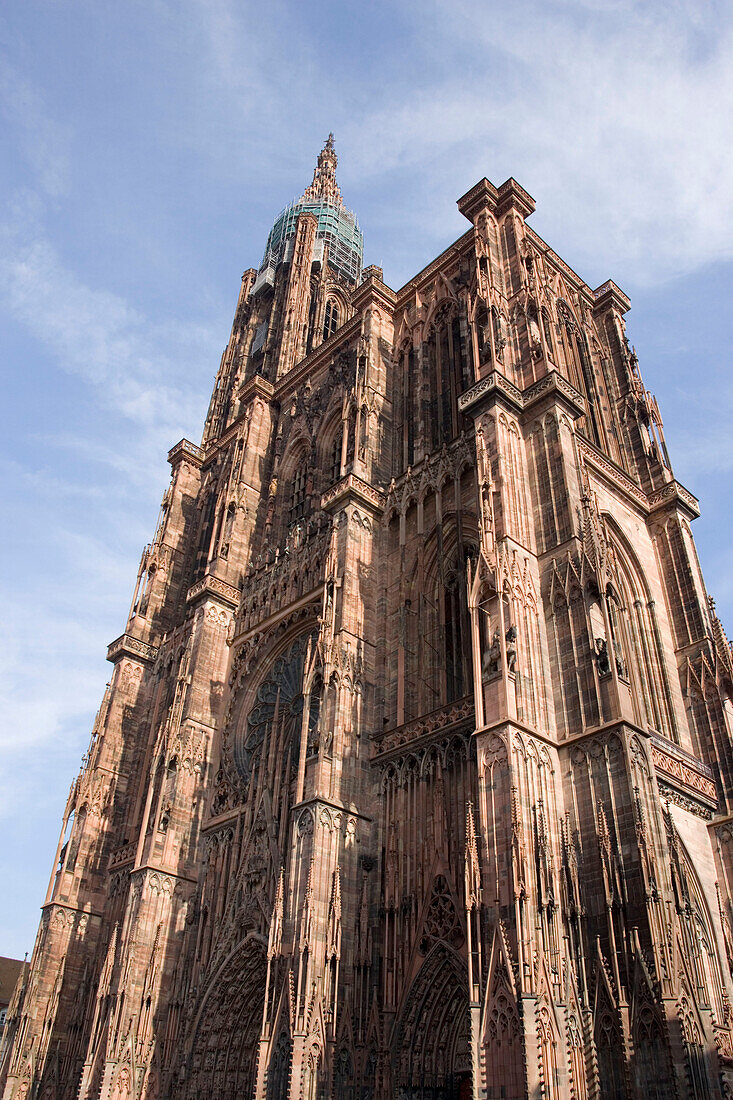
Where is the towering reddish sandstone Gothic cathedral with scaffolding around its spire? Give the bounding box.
[0,135,733,1100]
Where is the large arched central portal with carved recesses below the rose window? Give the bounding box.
[186,936,266,1100]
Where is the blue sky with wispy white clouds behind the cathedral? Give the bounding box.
[0,0,733,957]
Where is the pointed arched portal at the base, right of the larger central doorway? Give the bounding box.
[393,944,471,1100]
